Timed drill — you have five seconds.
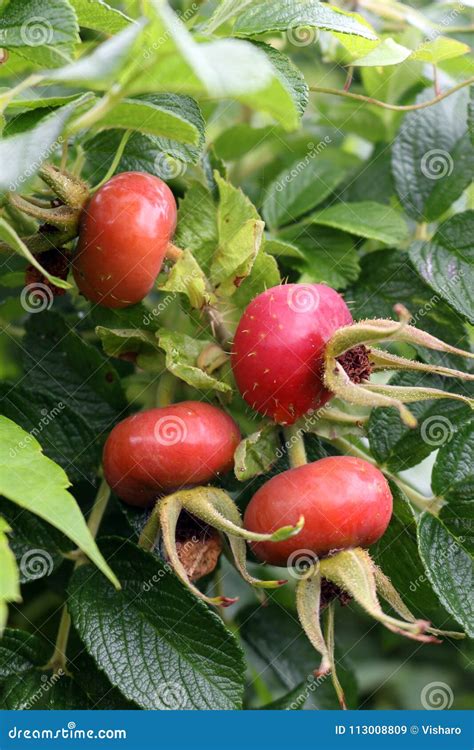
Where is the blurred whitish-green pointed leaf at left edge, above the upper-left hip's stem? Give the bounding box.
[0,94,89,194]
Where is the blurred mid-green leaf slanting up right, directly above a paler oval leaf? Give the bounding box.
[263,150,349,227]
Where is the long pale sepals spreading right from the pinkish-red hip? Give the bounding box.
[324,309,474,427]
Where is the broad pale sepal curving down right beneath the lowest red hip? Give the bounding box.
[320,547,437,643]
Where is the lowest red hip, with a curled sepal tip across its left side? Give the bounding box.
[244,456,392,566]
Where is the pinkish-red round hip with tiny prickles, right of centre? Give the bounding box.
[231,284,352,424]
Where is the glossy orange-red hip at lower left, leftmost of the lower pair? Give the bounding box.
[104,401,240,507]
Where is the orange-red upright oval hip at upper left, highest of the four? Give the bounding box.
[74,172,177,307]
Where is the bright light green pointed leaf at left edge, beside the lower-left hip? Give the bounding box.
[0,416,119,586]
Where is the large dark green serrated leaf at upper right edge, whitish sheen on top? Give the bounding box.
[392,90,474,221]
